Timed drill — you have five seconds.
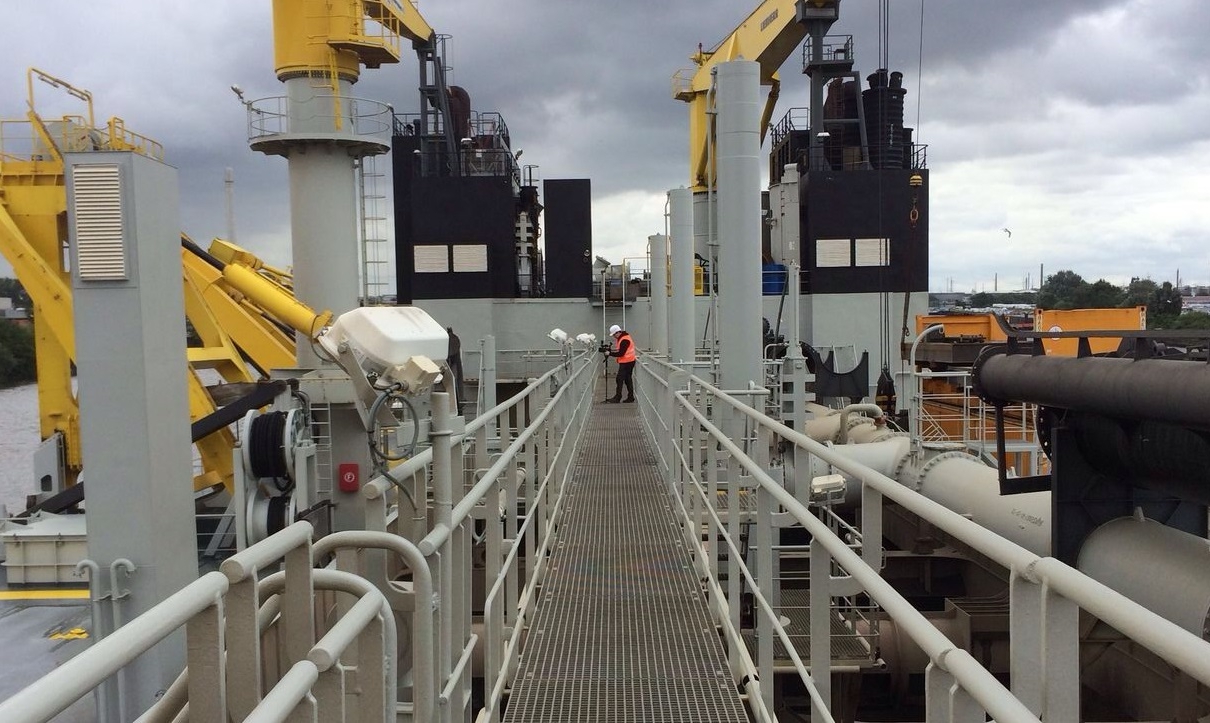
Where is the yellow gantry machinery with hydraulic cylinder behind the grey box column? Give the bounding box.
[0,69,332,498]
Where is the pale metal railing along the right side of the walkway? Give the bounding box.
[636,357,1210,722]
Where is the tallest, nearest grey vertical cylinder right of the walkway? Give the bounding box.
[716,60,764,389]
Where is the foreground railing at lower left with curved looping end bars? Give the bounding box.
[0,522,433,723]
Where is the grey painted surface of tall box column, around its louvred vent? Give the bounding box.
[67,152,197,719]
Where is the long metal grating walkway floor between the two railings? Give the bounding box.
[503,394,748,723]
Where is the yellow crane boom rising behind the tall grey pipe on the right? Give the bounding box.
[673,0,840,192]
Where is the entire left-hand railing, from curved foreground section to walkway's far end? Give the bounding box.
[0,352,600,723]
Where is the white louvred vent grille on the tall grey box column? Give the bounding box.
[71,166,128,282]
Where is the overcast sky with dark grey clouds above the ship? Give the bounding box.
[0,0,1210,291]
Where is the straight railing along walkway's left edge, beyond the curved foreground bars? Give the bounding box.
[363,352,600,721]
